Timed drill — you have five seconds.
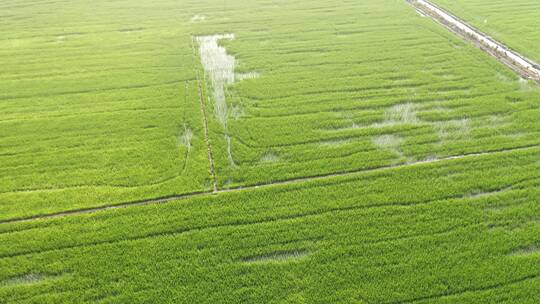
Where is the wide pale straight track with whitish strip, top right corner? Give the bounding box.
[405,0,540,84]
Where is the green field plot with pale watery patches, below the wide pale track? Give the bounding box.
[194,1,540,188]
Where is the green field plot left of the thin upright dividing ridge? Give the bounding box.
[0,1,210,220]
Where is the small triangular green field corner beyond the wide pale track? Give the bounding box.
[432,0,540,62]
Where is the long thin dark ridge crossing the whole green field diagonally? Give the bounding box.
[0,144,540,224]
